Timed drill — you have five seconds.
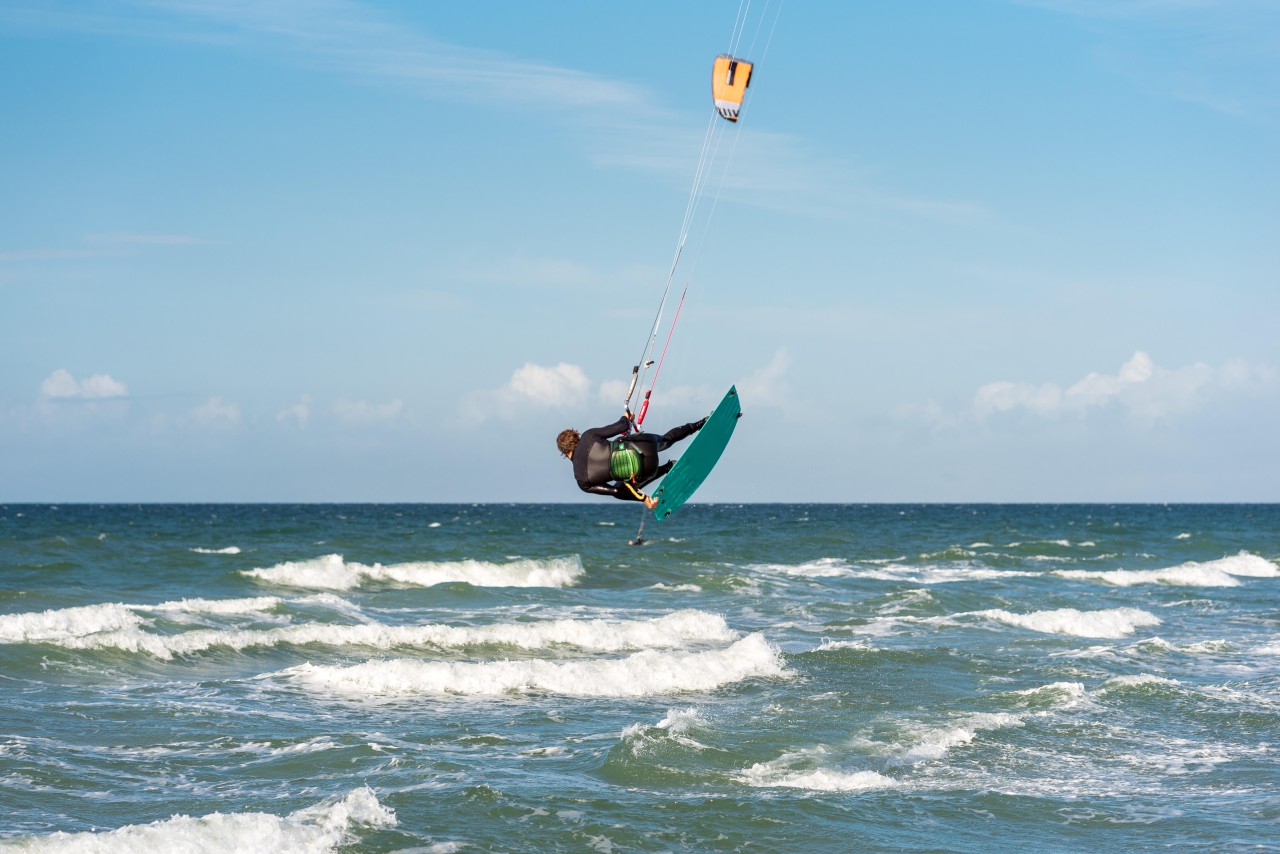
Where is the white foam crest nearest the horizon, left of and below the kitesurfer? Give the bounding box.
[242,554,584,590]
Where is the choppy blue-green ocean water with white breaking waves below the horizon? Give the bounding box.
[0,501,1280,851]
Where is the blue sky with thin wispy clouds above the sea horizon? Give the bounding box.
[0,0,1280,502]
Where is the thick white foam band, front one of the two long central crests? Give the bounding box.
[274,634,787,698]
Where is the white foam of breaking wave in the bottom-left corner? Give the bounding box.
[5,787,396,854]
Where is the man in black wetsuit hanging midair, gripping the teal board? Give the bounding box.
[556,411,707,510]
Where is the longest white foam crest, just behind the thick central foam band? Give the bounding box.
[60,609,739,658]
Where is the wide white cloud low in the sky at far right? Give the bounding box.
[967,351,1275,423]
